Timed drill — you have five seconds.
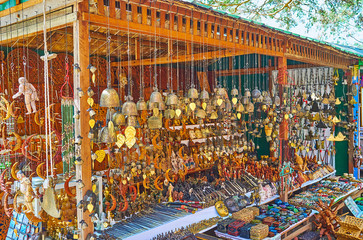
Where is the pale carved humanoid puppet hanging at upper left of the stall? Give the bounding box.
[13,77,39,114]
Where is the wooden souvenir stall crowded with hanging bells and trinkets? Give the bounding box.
[0,0,362,240]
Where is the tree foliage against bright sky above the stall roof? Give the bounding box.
[199,0,363,46]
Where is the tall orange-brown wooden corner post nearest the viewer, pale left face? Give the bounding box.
[73,1,93,239]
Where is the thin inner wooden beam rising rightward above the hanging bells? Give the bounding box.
[111,50,246,67]
